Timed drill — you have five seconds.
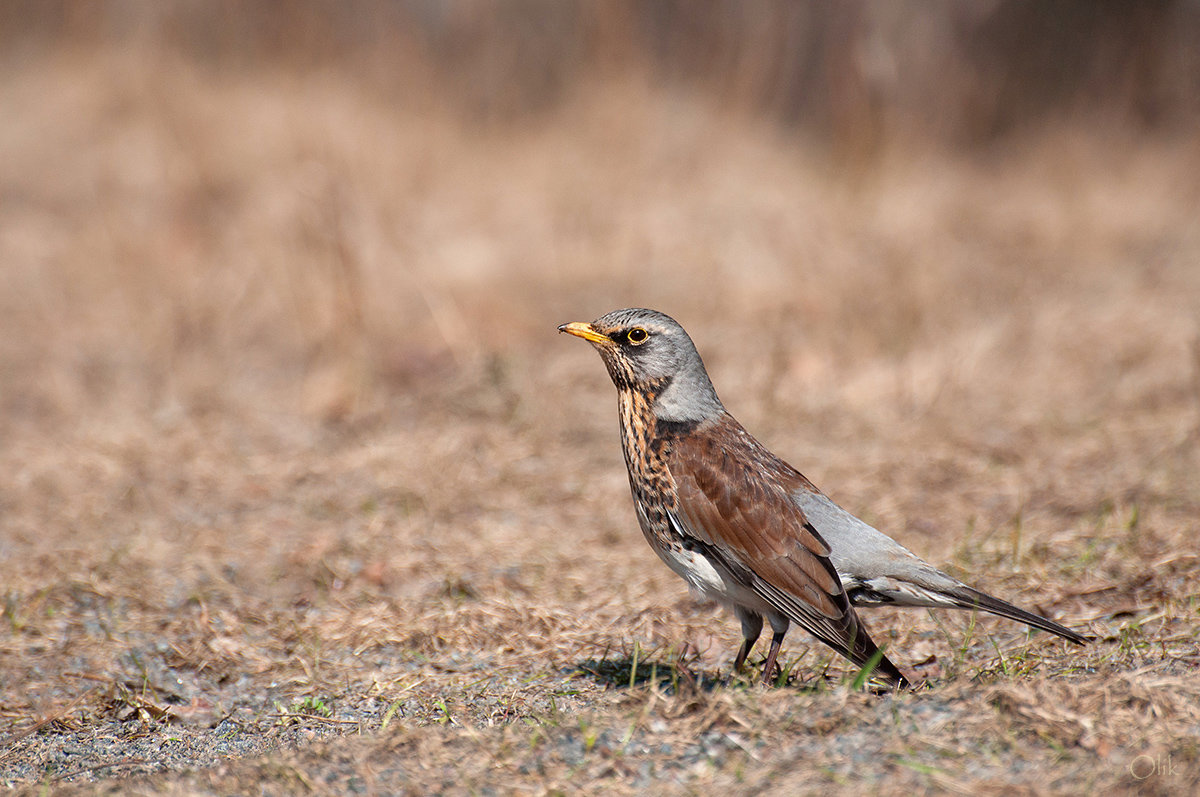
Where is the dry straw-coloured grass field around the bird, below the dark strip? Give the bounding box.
[0,46,1200,795]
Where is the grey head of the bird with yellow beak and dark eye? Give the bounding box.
[558,307,724,421]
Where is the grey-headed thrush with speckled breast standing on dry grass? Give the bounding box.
[558,307,1088,688]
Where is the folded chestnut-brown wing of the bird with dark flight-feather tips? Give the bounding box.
[668,418,902,677]
